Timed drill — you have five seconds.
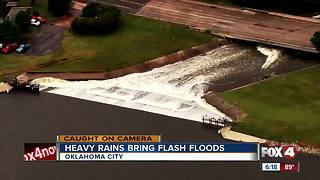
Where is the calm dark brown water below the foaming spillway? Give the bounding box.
[0,92,320,180]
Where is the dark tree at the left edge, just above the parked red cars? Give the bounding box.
[0,21,21,42]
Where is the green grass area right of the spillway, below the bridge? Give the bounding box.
[219,66,320,145]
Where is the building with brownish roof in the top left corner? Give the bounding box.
[0,0,31,23]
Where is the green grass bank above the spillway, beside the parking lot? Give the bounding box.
[0,15,215,75]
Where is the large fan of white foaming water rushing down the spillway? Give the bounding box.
[33,45,278,122]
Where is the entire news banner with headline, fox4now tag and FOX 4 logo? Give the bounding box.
[24,135,300,172]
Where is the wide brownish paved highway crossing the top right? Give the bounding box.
[133,0,320,52]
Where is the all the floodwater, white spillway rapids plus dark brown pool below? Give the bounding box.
[0,45,320,180]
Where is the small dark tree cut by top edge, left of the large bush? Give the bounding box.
[48,0,72,16]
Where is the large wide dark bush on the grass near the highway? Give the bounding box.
[71,3,121,34]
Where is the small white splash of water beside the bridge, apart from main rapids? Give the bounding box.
[257,46,281,69]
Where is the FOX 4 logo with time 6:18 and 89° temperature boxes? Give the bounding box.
[260,146,300,173]
